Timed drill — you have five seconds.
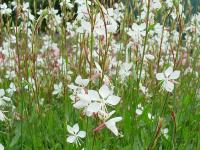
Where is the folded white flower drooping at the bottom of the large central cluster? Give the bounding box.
[105,117,122,136]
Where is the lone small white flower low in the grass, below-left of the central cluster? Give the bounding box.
[67,124,86,145]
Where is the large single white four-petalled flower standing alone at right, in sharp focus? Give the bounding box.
[156,67,180,92]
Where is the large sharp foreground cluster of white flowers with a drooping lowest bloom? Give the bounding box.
[69,76,122,141]
